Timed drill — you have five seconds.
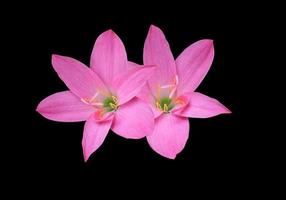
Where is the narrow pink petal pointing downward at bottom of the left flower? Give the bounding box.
[82,115,112,161]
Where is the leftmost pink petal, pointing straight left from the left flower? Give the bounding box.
[37,91,95,122]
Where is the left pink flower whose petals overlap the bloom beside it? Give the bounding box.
[37,30,154,161]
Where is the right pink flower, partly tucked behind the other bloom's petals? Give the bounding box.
[138,25,231,159]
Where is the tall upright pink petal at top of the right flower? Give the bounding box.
[143,25,176,89]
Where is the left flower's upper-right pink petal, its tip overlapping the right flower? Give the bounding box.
[115,66,155,105]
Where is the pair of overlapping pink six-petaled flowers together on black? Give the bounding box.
[37,25,230,161]
